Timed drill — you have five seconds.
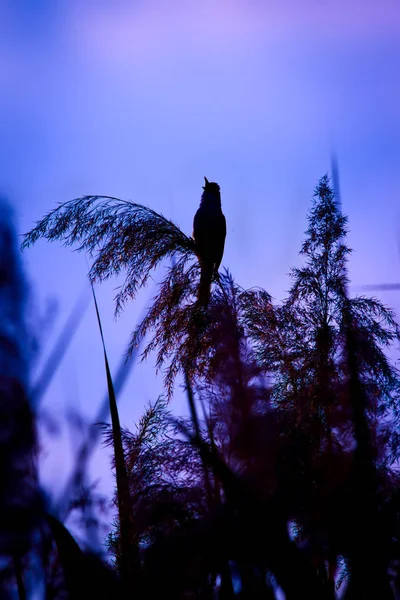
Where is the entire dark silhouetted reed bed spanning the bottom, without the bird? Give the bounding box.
[0,176,400,600]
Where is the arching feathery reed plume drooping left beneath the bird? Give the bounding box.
[22,196,230,396]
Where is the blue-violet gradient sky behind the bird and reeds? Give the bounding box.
[0,0,400,544]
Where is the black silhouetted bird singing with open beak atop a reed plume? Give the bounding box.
[193,177,226,306]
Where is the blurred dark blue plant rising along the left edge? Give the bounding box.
[0,202,43,598]
